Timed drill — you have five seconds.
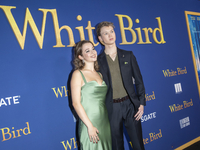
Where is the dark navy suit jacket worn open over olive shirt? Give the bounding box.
[98,48,146,119]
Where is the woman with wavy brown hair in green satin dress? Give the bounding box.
[71,40,112,150]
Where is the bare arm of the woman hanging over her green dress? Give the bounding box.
[71,70,99,143]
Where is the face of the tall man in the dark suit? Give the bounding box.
[98,26,116,45]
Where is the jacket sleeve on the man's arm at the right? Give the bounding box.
[130,52,146,106]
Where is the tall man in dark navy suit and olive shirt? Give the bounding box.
[97,21,146,150]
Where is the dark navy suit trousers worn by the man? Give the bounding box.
[110,99,144,150]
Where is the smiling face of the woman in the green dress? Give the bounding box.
[79,43,97,62]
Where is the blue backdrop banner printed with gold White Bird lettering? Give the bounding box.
[0,0,200,150]
